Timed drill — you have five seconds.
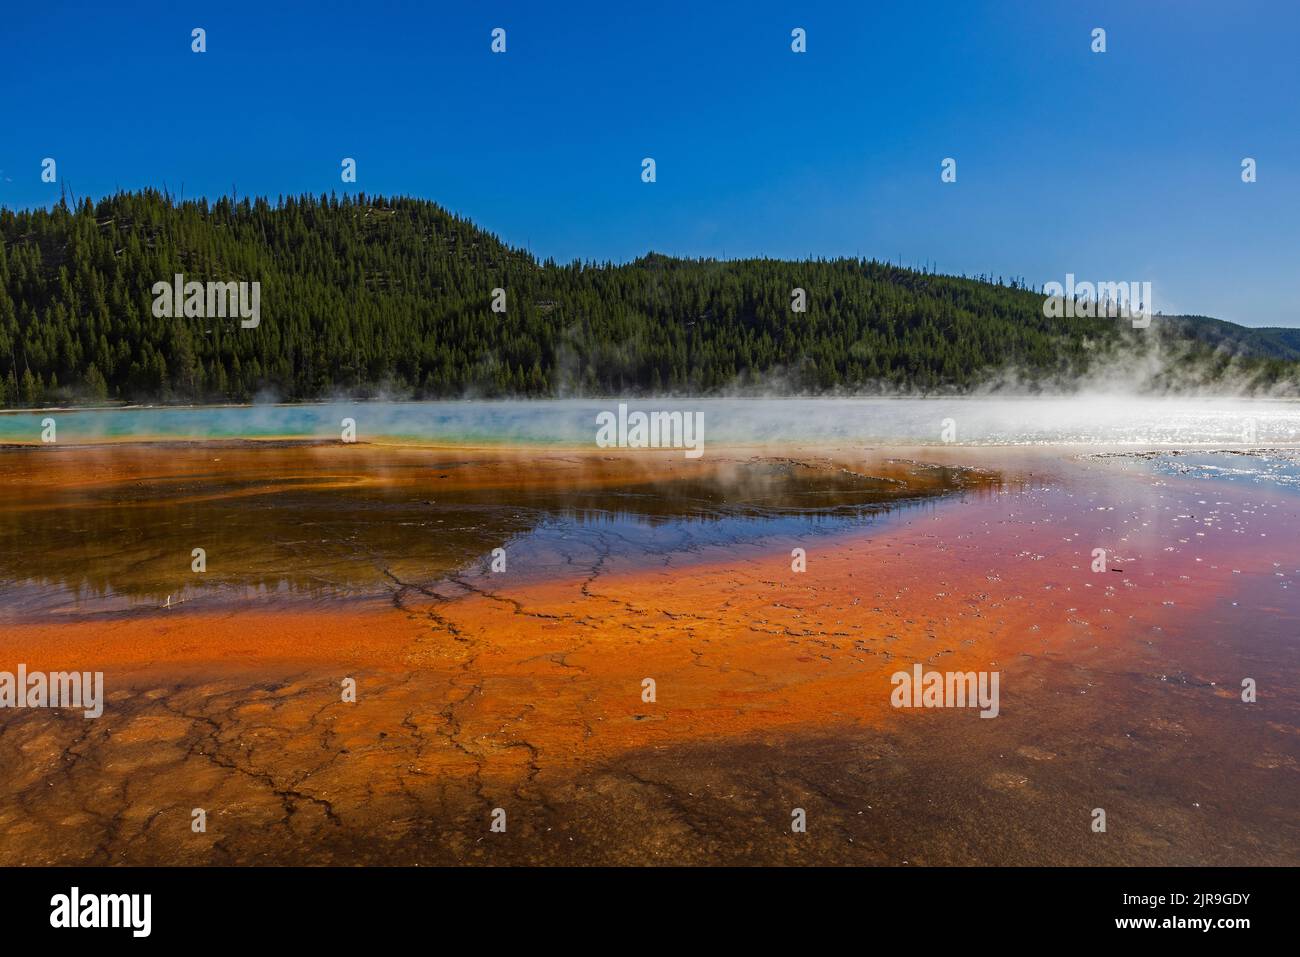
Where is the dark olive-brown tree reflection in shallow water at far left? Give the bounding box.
[0,493,534,603]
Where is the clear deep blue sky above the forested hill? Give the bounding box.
[0,0,1300,325]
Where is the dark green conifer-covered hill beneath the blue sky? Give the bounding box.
[0,191,1296,407]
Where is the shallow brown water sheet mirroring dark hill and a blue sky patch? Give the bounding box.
[0,443,1001,618]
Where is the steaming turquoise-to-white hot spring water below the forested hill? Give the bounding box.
[0,395,1300,447]
